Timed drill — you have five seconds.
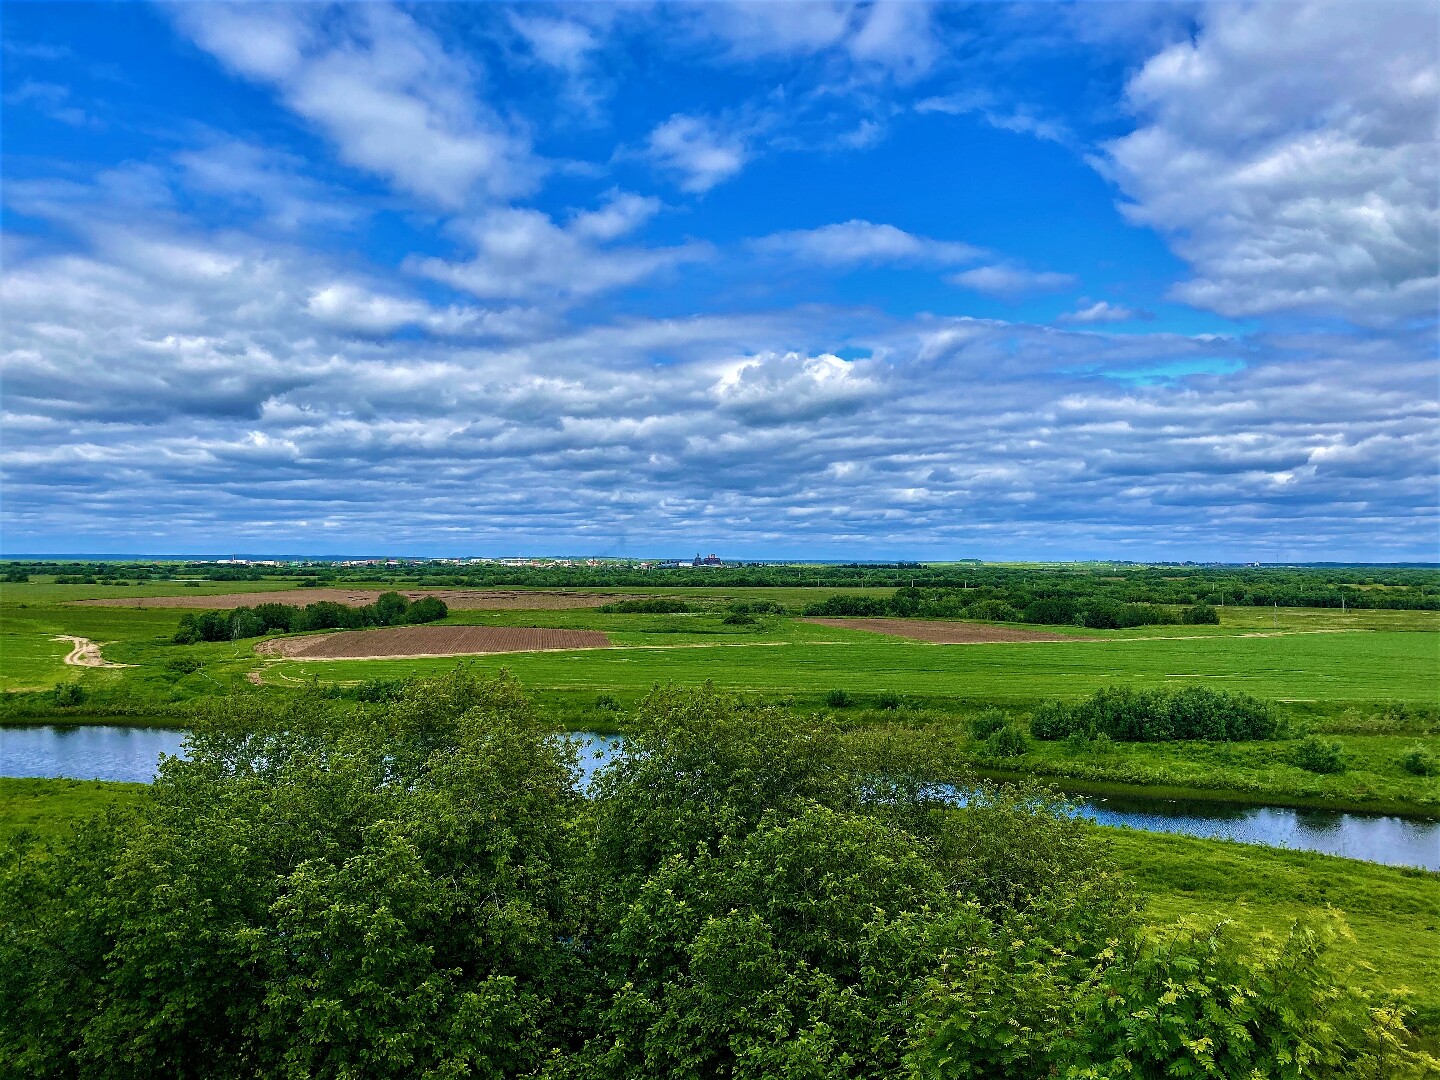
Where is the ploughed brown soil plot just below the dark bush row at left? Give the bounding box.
[255,626,611,660]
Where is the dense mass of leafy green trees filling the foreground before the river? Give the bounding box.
[0,670,1427,1080]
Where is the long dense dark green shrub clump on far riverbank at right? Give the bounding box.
[1030,687,1279,743]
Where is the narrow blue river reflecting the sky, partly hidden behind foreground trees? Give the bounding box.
[0,726,1440,870]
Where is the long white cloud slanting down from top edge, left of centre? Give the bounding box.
[174,4,537,209]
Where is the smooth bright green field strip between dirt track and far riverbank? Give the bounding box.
[266,622,1440,704]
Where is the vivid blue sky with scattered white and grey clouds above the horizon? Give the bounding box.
[0,0,1440,562]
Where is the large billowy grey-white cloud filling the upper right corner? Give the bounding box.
[1099,1,1440,323]
